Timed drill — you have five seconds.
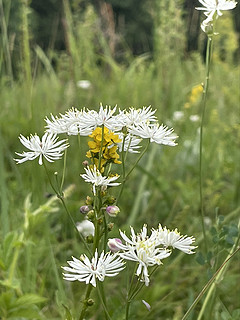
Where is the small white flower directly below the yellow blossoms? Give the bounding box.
[80,166,120,194]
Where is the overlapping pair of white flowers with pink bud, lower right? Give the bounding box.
[108,225,196,286]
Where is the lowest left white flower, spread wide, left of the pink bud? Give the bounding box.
[62,250,124,287]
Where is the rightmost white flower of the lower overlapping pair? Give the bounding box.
[156,224,197,254]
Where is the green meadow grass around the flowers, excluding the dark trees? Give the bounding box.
[0,1,240,320]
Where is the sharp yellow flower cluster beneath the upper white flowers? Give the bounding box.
[86,127,121,172]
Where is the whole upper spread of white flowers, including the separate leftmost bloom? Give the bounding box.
[15,105,178,166]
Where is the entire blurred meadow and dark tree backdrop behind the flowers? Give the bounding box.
[0,0,240,320]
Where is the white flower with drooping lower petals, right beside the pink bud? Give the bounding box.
[115,225,171,286]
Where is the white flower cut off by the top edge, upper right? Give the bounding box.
[196,0,237,32]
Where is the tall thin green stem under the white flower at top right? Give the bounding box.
[199,36,213,253]
